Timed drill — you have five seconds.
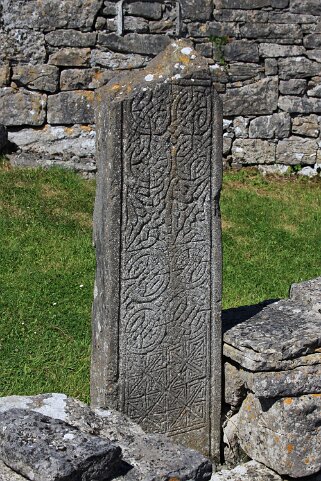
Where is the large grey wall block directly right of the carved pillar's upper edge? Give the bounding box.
[222,77,278,115]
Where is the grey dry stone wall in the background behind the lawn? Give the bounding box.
[0,0,321,175]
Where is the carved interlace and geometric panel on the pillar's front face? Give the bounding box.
[120,81,213,434]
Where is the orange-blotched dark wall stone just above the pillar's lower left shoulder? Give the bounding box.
[60,68,114,90]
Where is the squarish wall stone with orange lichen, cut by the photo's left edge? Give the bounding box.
[0,87,47,127]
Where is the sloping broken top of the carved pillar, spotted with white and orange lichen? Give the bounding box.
[97,40,221,100]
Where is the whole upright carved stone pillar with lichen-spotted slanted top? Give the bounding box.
[91,41,222,458]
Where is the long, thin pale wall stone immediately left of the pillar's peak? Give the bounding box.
[91,49,149,70]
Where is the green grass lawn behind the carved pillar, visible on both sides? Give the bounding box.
[0,167,321,401]
